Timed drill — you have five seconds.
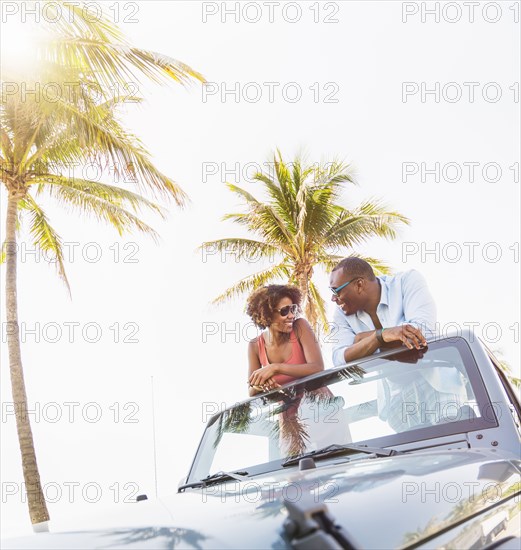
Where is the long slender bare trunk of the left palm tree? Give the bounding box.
[5,190,49,524]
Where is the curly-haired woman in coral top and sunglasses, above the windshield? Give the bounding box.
[246,285,324,396]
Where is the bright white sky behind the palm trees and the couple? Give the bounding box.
[1,0,520,535]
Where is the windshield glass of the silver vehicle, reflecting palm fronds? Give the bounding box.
[188,338,497,481]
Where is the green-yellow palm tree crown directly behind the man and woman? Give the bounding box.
[201,151,409,330]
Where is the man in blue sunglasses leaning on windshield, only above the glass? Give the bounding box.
[330,256,436,367]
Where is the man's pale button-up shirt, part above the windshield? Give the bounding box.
[331,269,436,367]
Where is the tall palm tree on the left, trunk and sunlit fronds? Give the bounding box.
[0,2,203,524]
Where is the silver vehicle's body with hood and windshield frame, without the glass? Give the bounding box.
[2,332,521,550]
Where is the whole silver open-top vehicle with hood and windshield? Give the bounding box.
[2,332,521,550]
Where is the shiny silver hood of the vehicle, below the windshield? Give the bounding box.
[2,449,521,549]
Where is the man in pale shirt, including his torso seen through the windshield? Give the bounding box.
[330,257,466,432]
